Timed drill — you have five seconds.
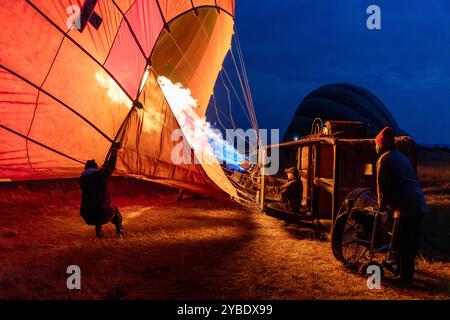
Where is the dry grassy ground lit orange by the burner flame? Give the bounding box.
[0,149,450,299]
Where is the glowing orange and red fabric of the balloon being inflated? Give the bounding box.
[0,0,236,197]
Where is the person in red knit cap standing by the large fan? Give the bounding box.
[375,127,427,283]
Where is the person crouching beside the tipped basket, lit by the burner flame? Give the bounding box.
[280,167,303,212]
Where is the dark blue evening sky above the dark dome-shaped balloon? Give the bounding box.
[229,0,450,143]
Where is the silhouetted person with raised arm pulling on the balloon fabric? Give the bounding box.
[80,143,123,239]
